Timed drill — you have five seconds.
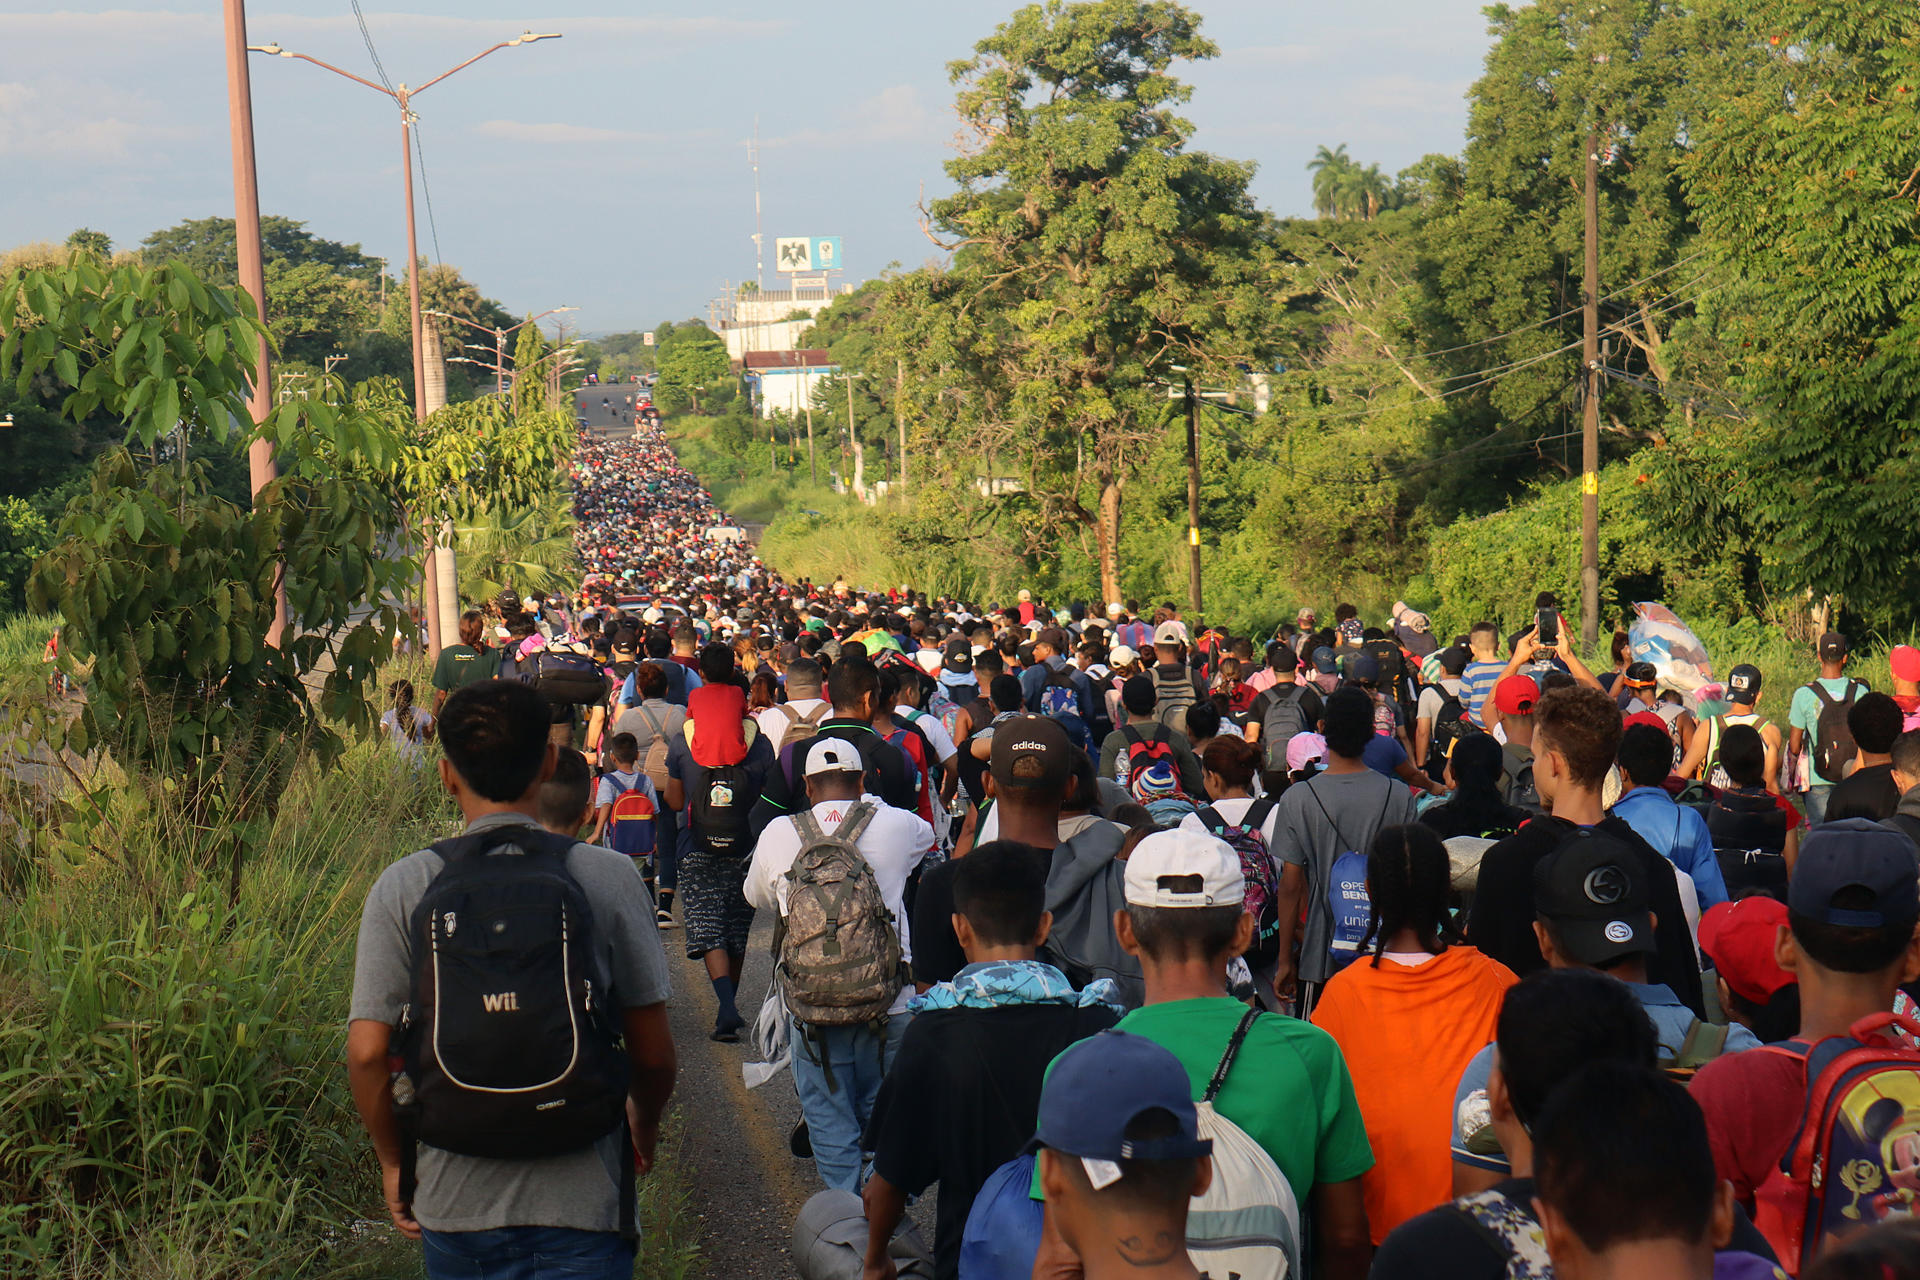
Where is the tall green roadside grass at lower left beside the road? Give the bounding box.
[0,652,697,1280]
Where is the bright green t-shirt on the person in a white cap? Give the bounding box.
[1117,996,1373,1203]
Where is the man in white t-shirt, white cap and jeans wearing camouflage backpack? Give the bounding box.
[745,737,933,1192]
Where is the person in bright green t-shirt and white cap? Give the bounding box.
[1114,831,1373,1280]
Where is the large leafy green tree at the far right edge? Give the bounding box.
[1670,0,1920,620]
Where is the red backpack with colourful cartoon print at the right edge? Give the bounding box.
[1749,1013,1920,1274]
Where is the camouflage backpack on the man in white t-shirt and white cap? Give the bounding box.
[774,804,906,1027]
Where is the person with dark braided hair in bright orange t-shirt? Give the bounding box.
[1313,823,1517,1244]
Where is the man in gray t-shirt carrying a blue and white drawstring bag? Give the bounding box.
[1273,687,1415,1017]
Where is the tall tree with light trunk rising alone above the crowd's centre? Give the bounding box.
[929,0,1263,599]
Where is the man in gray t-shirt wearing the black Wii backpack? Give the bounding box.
[348,681,674,1280]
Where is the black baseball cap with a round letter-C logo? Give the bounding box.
[1534,829,1655,965]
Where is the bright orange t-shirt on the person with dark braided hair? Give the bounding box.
[1313,946,1519,1244]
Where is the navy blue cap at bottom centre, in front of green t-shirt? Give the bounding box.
[1027,1031,1213,1161]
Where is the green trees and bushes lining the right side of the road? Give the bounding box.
[672,0,1920,639]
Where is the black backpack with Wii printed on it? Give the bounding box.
[394,823,632,1230]
